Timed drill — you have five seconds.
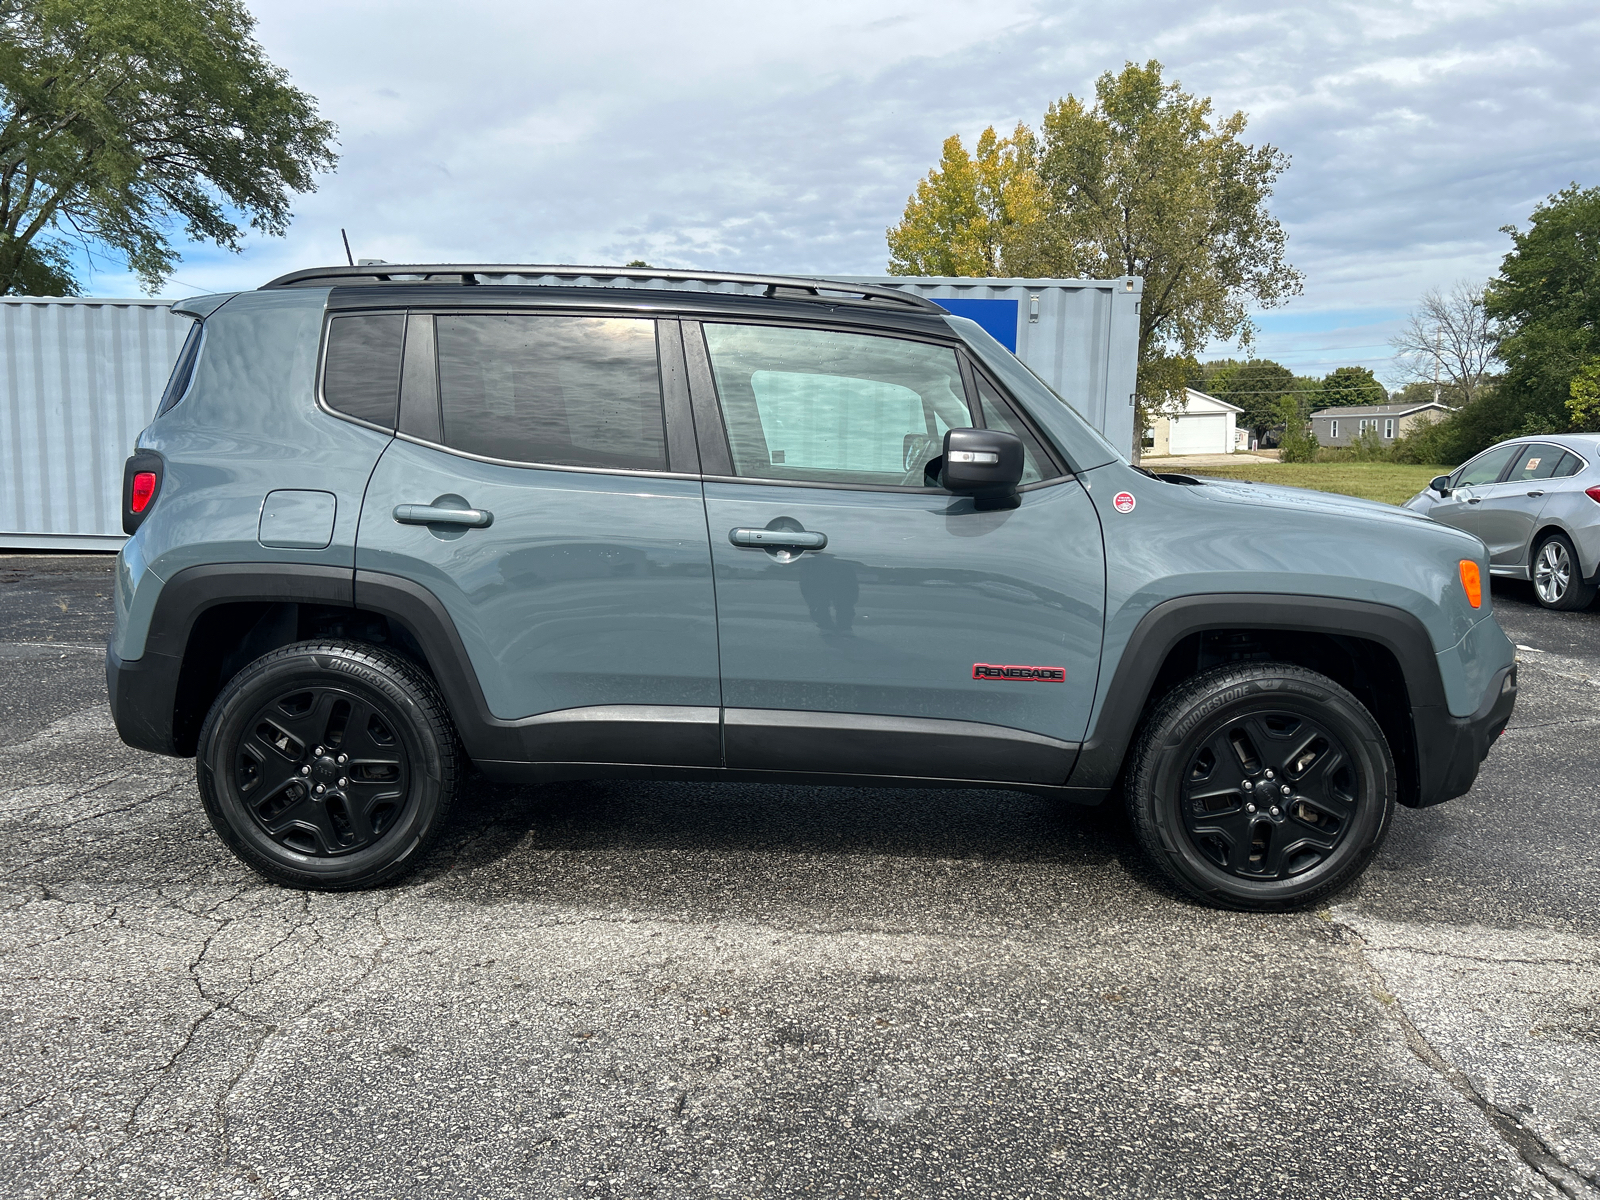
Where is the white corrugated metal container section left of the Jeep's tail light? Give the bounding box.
[0,296,194,550]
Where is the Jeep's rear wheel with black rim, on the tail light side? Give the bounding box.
[195,642,459,891]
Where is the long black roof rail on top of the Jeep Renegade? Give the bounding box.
[262,262,944,315]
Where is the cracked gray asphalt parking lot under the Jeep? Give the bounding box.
[0,555,1600,1198]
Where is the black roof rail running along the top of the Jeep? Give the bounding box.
[262,262,946,315]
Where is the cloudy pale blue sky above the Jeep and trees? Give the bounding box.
[90,0,1600,382]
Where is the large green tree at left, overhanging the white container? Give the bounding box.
[0,0,336,294]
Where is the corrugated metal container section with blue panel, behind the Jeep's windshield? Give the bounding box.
[829,275,1144,456]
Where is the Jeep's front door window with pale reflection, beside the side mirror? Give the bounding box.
[704,325,973,488]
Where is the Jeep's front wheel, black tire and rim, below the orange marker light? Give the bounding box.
[1126,662,1395,912]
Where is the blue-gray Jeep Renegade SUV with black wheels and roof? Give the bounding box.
[107,266,1517,909]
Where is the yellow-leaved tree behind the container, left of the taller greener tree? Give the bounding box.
[888,123,1042,275]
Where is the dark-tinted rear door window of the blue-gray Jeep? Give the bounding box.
[435,315,667,470]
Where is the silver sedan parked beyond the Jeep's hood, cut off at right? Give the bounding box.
[1405,434,1600,611]
